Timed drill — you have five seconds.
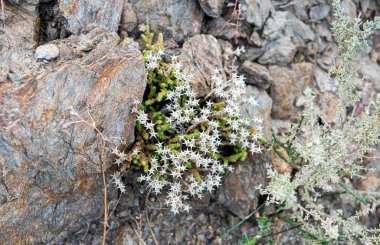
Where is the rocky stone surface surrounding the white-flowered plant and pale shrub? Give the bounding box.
[0,0,380,244]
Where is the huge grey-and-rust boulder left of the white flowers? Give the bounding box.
[0,29,146,244]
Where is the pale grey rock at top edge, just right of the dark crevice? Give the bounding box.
[59,0,124,35]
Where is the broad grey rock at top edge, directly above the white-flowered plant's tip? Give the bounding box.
[133,0,204,42]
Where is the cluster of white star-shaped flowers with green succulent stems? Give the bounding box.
[112,25,262,213]
